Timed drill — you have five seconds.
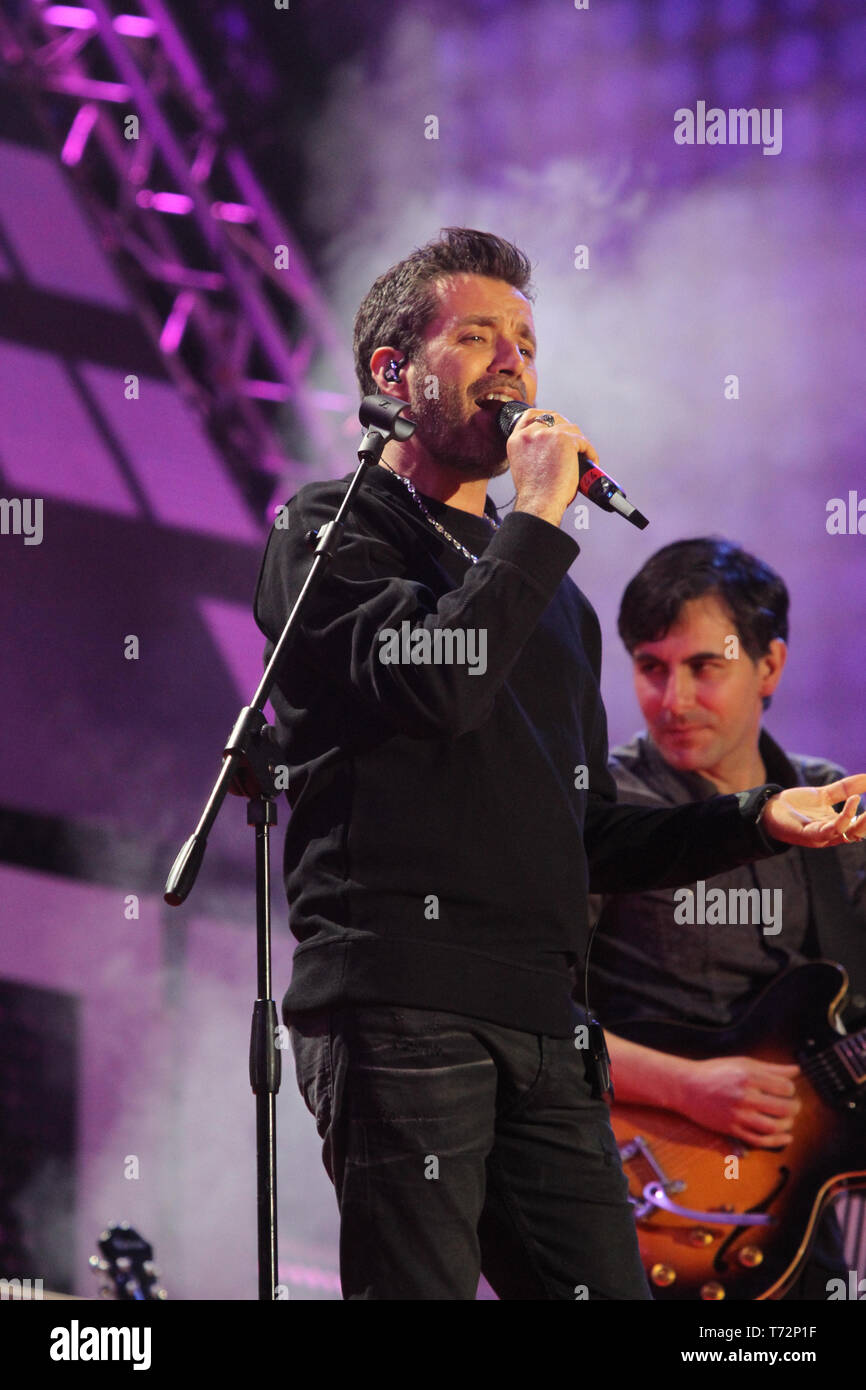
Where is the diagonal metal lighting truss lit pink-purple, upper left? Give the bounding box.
[0,0,357,516]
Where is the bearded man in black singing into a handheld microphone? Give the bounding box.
[256,228,866,1300]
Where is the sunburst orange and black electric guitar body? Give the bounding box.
[610,960,866,1301]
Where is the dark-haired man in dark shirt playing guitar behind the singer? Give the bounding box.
[589,539,866,1300]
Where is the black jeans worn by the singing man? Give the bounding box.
[289,1005,651,1300]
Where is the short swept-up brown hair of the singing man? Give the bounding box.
[354,227,534,396]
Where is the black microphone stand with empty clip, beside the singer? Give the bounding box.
[164,396,416,1301]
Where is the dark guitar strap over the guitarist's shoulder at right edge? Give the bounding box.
[801,849,866,1030]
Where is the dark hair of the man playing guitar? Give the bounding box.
[617,537,790,709]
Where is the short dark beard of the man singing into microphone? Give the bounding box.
[407,359,509,480]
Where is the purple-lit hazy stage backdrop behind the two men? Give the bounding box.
[0,0,866,1298]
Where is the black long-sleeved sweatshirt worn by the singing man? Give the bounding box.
[256,466,784,1037]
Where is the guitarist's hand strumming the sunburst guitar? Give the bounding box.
[676,1056,801,1148]
